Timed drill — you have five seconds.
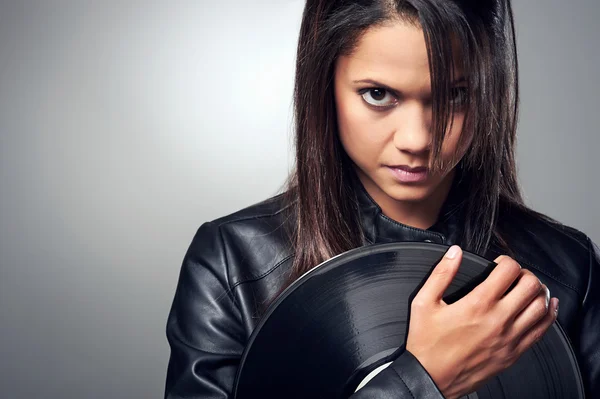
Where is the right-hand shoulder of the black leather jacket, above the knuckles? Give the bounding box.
[490,207,594,296]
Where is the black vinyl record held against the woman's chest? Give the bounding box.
[235,242,584,399]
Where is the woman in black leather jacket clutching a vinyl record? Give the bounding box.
[166,0,600,398]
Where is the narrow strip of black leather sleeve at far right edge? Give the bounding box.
[576,238,600,398]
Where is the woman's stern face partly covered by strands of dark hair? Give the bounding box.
[335,22,467,220]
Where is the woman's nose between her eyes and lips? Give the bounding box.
[394,101,431,156]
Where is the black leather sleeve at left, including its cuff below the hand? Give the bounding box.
[165,223,443,399]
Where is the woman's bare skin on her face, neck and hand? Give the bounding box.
[335,21,558,399]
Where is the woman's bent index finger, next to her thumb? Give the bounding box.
[467,255,521,301]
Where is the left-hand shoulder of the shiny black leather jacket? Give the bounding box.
[186,194,293,288]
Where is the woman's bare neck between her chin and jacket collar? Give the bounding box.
[359,170,455,230]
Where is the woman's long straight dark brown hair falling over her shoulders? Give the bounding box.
[286,0,526,292]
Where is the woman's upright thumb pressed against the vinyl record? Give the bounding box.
[415,245,462,302]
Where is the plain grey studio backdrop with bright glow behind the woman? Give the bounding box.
[0,0,600,398]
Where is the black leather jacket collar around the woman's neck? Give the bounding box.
[353,174,463,245]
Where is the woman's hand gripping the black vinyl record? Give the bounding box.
[406,246,558,399]
